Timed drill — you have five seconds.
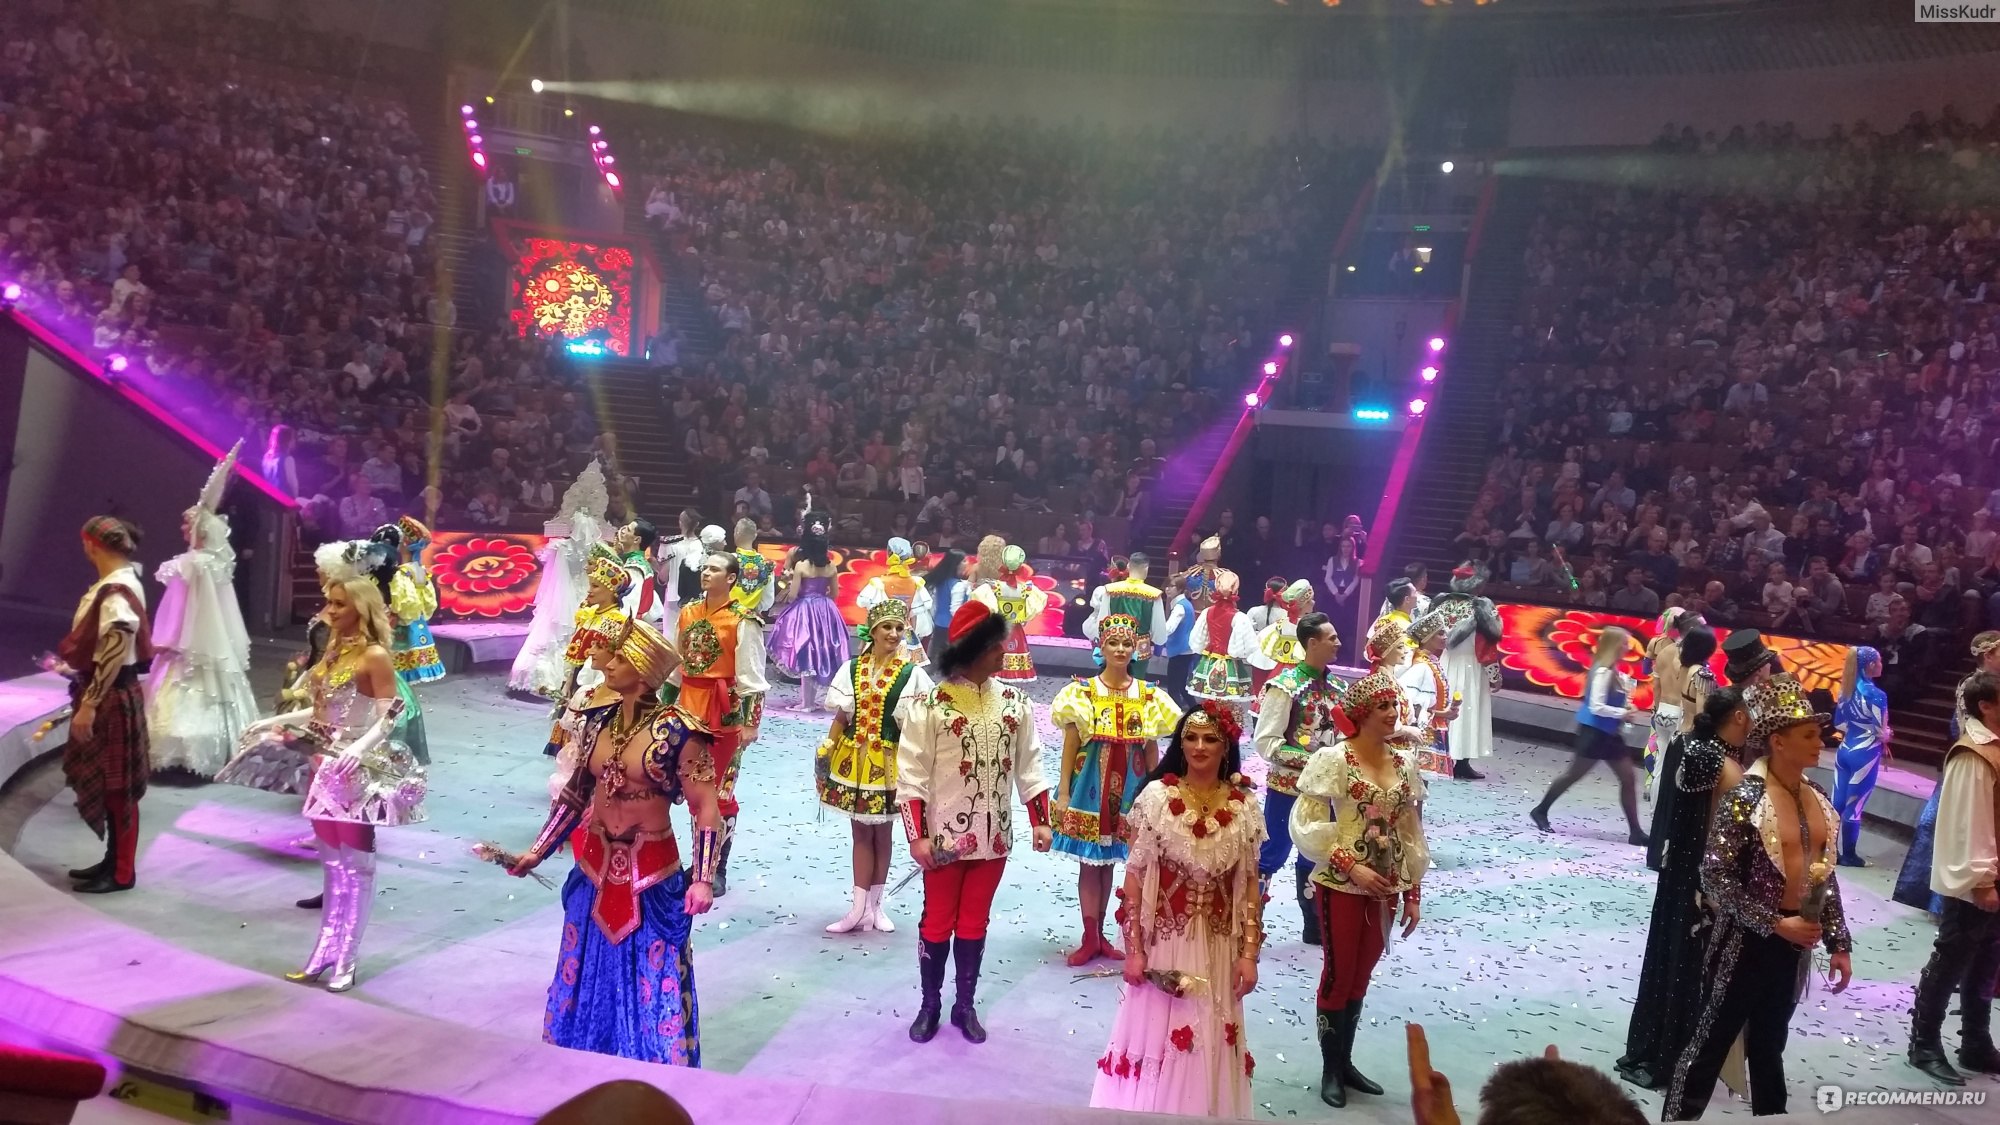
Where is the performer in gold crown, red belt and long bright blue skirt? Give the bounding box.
[510,612,726,1067]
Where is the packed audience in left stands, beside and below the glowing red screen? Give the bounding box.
[0,0,600,534]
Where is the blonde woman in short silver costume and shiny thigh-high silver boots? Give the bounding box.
[218,564,426,993]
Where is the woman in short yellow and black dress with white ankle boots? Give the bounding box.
[814,599,930,933]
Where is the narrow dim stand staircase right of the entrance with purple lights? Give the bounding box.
[1376,176,1536,575]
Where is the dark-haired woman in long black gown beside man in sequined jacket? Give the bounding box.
[1618,684,1750,1089]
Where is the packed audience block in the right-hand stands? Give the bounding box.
[1458,110,2000,696]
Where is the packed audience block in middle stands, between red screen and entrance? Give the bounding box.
[622,124,1364,546]
